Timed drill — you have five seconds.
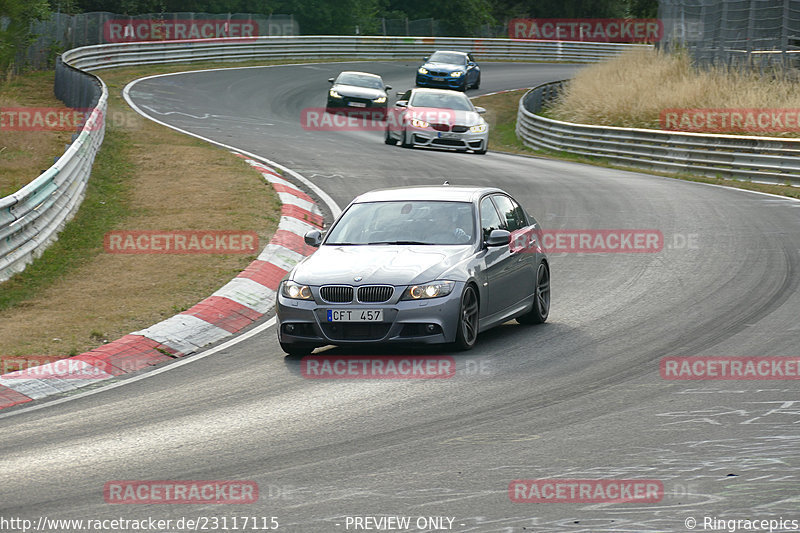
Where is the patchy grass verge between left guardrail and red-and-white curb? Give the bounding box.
[0,65,288,356]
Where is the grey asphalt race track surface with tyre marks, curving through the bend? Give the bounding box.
[0,62,800,533]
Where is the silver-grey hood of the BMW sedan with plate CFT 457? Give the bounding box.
[291,244,472,285]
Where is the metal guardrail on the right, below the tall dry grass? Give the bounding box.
[516,81,800,185]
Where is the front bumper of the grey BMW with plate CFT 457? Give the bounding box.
[275,282,464,346]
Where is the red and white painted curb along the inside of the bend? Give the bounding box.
[0,152,324,409]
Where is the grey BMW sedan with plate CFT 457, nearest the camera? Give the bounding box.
[277,185,550,355]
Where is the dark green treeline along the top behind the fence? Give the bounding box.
[0,0,658,72]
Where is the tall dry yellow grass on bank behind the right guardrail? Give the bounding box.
[548,50,800,135]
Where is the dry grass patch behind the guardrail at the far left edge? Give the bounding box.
[0,72,70,198]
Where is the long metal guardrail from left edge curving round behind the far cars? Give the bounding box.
[0,36,647,282]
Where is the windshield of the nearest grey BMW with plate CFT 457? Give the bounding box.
[325,200,475,245]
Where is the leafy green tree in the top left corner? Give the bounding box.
[0,0,50,78]
